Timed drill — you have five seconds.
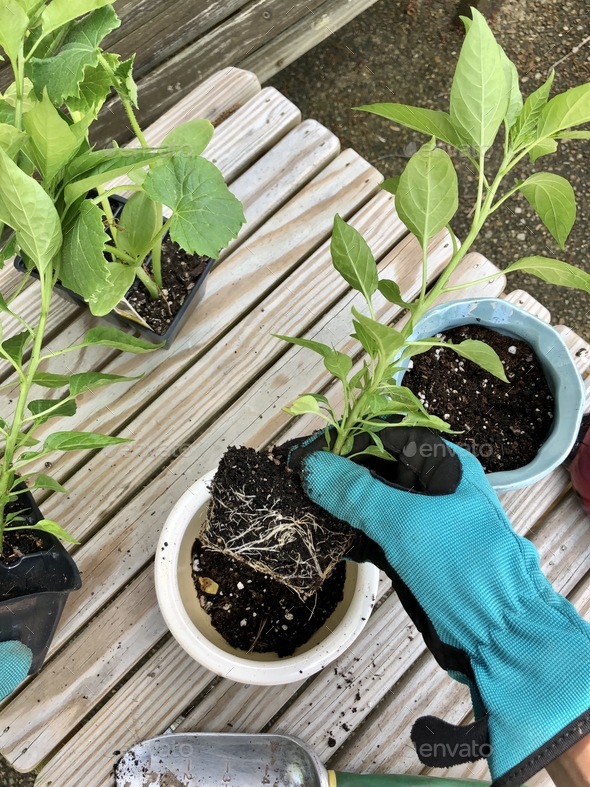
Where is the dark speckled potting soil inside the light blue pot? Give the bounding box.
[403,325,554,473]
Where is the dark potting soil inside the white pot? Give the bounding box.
[192,540,346,657]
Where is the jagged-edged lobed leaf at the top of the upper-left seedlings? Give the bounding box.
[27,6,121,109]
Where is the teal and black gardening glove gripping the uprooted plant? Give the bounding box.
[289,427,590,787]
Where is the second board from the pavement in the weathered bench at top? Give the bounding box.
[93,0,328,143]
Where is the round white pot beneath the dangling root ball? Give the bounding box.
[155,471,379,686]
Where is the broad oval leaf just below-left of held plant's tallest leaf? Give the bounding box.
[395,141,459,245]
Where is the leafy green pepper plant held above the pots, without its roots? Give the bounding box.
[279,9,590,459]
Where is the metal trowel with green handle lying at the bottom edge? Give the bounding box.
[116,732,489,787]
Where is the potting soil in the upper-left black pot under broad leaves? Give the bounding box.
[127,236,209,334]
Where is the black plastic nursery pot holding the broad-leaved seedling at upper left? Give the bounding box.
[14,196,215,350]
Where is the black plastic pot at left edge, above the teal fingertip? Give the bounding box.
[0,494,82,675]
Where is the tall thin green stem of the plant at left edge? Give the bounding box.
[0,265,52,553]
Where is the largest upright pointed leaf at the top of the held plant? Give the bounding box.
[451,8,509,152]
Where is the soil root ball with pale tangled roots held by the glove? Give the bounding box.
[201,447,354,599]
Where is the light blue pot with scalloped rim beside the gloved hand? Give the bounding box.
[400,298,586,492]
